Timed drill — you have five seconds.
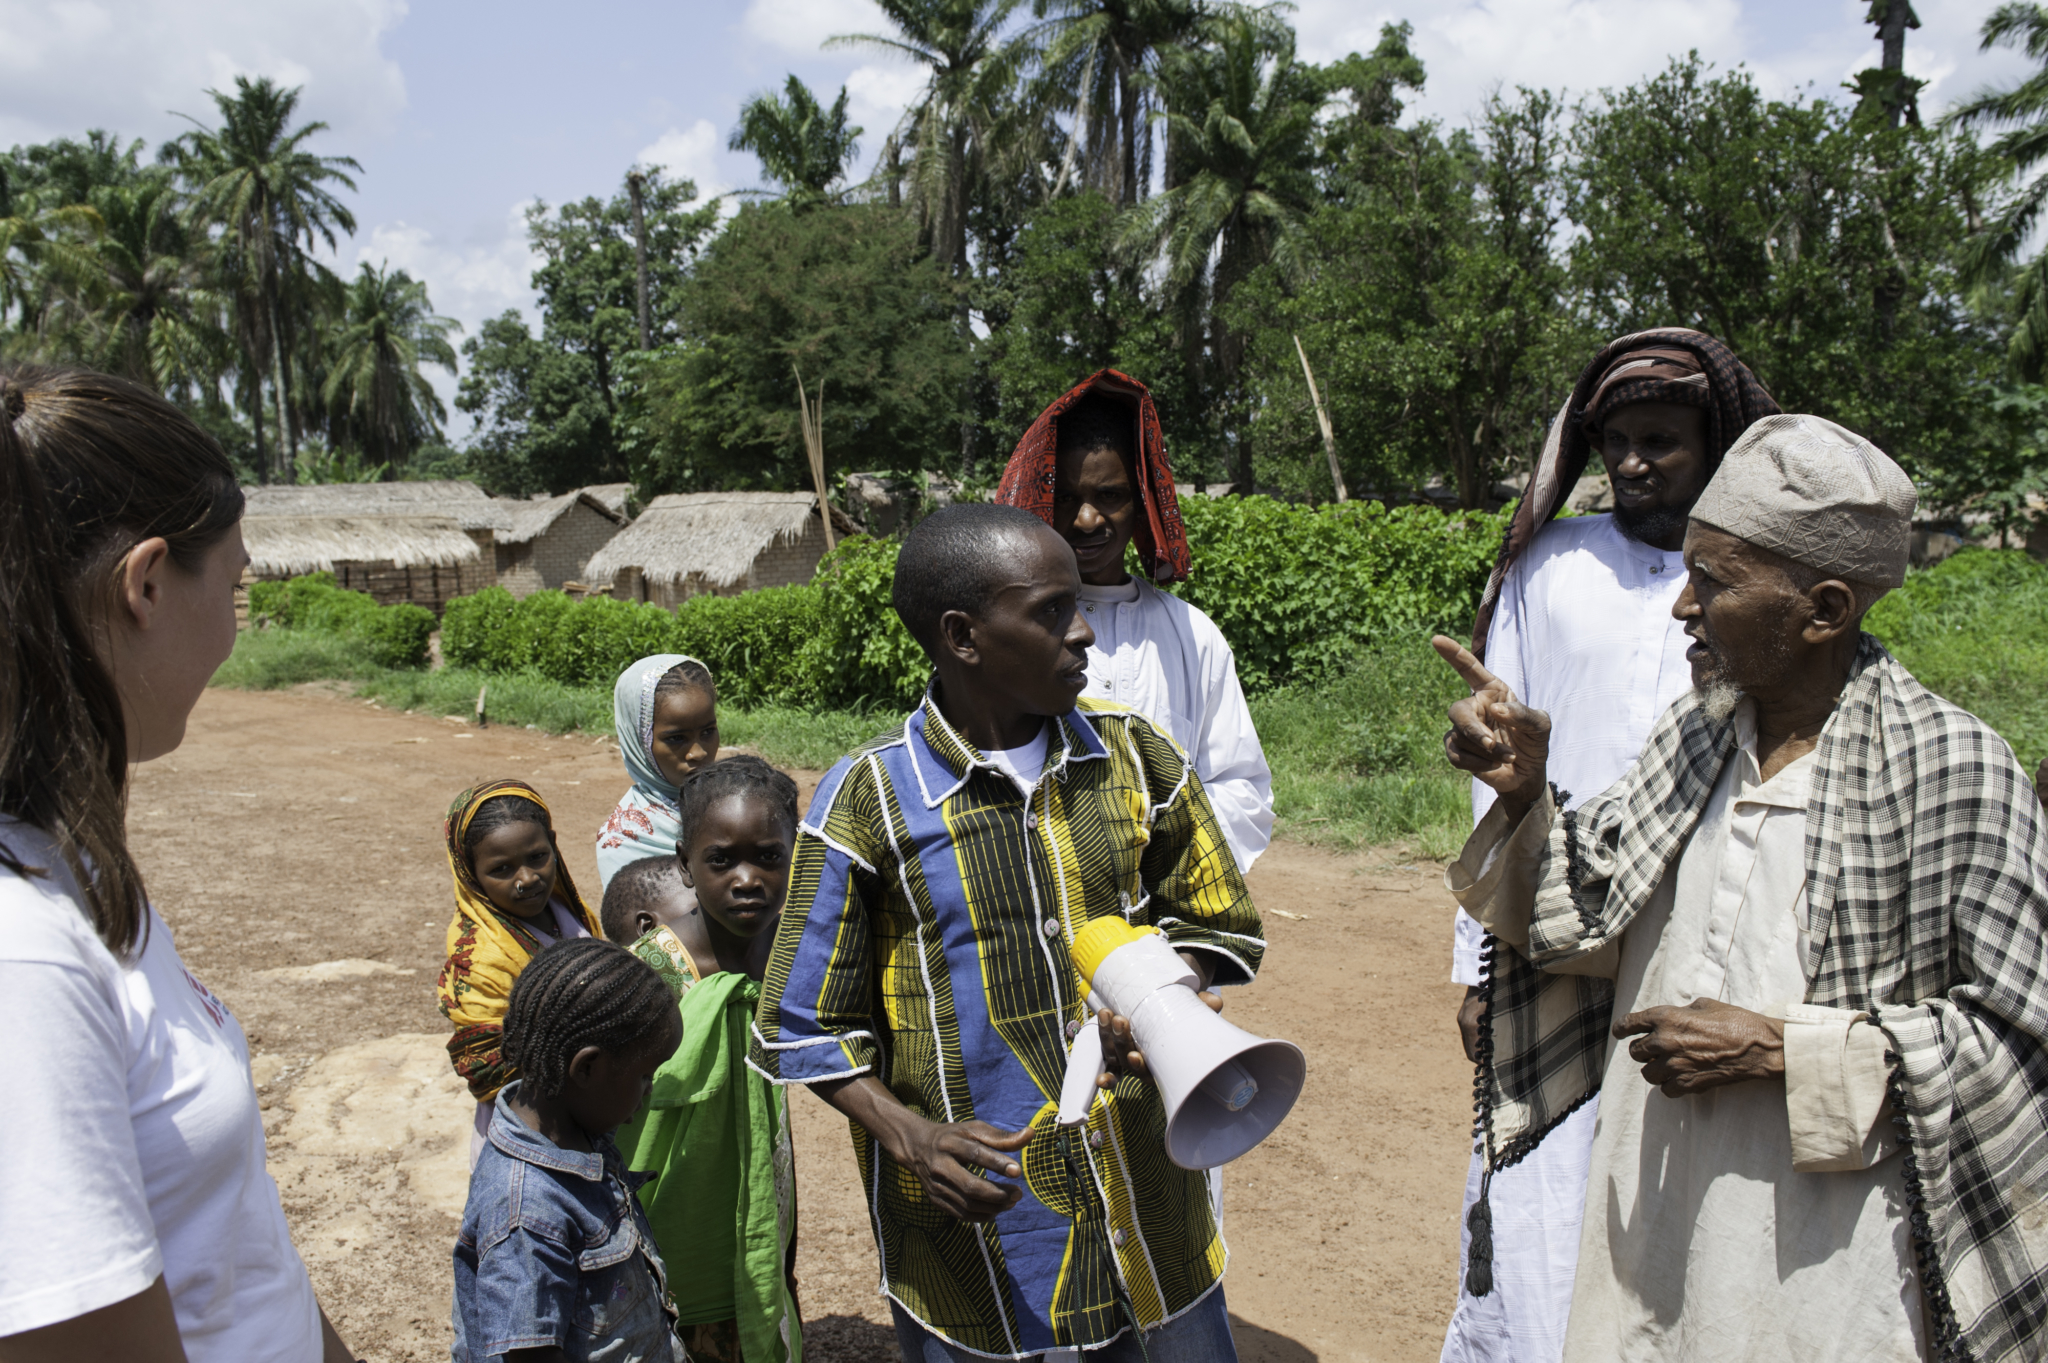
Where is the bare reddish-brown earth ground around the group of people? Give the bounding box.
[131,686,1470,1363]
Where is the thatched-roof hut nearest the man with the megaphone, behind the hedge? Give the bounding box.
[584,491,858,606]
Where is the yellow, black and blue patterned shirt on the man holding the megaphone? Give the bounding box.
[750,696,1266,1357]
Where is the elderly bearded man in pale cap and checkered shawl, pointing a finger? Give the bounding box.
[1436,415,2048,1363]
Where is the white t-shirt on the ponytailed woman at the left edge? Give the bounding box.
[0,817,322,1363]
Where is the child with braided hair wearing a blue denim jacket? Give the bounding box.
[453,937,686,1363]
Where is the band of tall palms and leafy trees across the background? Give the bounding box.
[0,0,2048,528]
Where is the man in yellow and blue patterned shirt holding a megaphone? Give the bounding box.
[748,503,1300,1363]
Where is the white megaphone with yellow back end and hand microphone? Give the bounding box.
[1059,917,1309,1169]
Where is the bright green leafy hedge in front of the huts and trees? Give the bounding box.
[423,497,1505,708]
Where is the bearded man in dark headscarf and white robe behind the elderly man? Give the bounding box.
[1444,327,1778,1363]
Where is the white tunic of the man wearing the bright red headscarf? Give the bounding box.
[1081,577,1274,872]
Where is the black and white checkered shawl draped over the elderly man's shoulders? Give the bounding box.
[1475,634,2048,1363]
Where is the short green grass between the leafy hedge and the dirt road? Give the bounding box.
[213,548,2048,858]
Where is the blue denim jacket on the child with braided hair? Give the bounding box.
[453,1083,686,1363]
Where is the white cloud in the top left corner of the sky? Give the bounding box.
[0,0,406,149]
